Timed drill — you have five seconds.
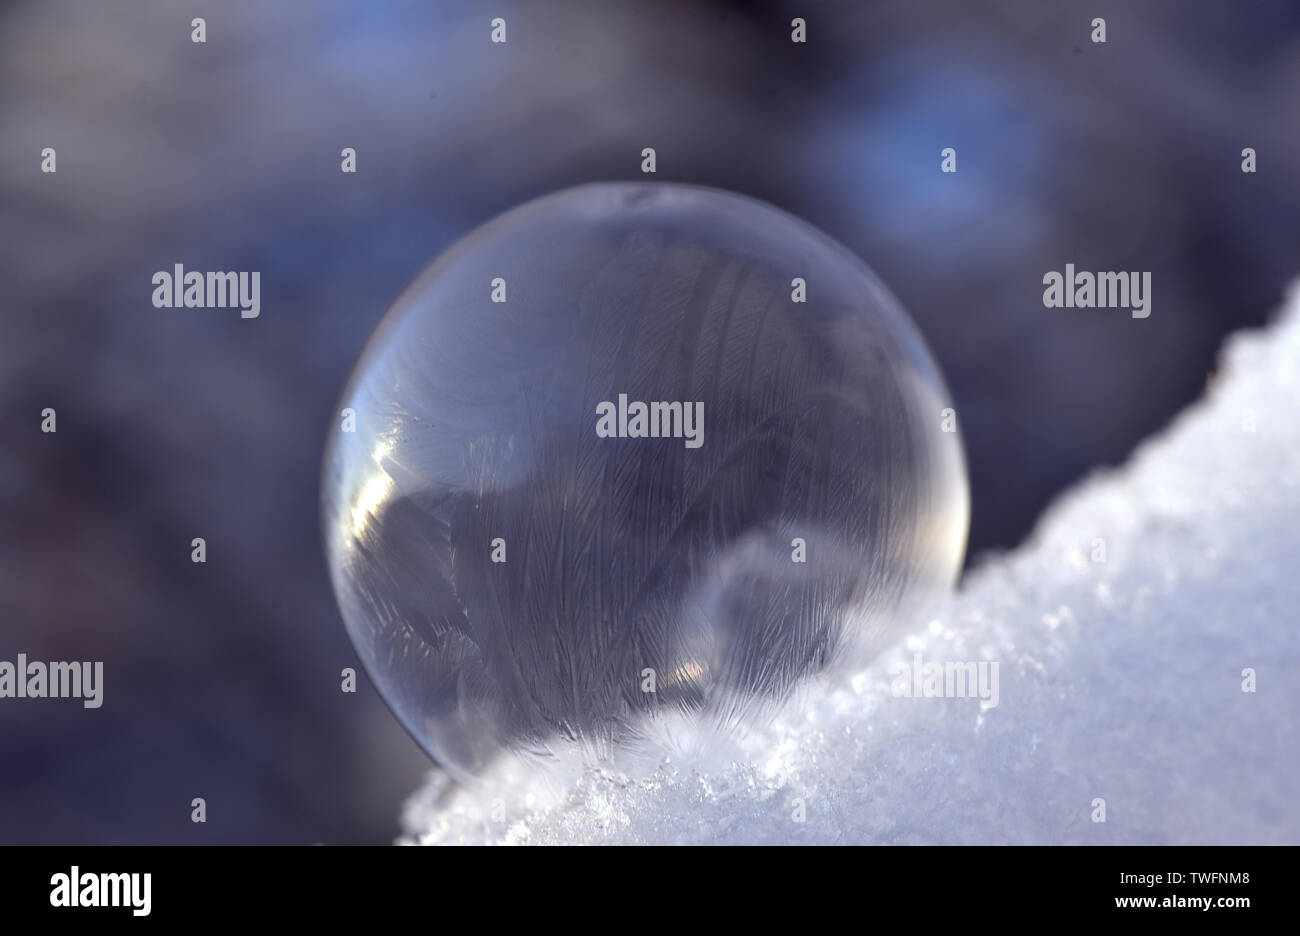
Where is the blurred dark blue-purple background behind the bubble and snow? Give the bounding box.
[0,0,1300,844]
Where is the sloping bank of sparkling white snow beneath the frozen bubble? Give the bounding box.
[403,282,1300,844]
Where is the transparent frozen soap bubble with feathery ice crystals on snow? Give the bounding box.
[324,185,967,783]
